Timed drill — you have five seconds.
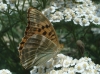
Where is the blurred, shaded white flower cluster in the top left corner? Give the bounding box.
[0,0,38,11]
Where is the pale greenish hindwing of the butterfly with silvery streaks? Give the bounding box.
[20,34,58,69]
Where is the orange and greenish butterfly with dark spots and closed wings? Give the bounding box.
[18,7,62,69]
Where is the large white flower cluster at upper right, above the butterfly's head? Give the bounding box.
[43,0,100,26]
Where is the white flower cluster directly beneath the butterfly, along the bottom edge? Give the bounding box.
[30,54,100,74]
